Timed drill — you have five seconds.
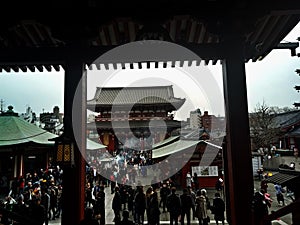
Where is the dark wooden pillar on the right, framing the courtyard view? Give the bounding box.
[222,35,254,225]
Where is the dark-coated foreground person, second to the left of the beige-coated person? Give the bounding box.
[167,187,181,225]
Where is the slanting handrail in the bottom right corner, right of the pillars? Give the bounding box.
[260,198,300,225]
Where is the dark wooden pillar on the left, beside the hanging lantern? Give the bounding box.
[61,53,86,225]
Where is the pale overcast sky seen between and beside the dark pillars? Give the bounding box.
[0,21,300,120]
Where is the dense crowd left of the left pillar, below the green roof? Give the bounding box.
[1,167,63,225]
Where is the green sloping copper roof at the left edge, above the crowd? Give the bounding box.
[0,116,57,147]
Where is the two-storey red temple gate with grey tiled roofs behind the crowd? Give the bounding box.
[87,85,185,152]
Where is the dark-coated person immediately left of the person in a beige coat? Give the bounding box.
[180,188,193,225]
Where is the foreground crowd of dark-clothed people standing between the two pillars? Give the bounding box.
[86,172,225,225]
